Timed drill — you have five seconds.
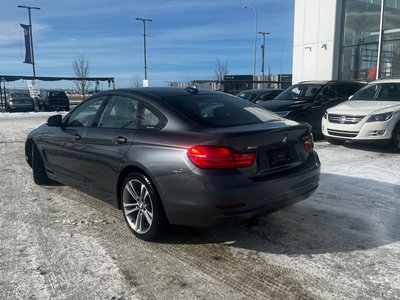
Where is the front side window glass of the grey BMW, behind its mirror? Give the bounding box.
[67,96,108,127]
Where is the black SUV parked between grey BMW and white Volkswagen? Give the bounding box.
[260,80,364,134]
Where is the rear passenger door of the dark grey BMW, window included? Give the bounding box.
[80,95,138,194]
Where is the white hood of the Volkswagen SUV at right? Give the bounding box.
[328,100,400,116]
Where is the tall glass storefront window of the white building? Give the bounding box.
[339,0,400,81]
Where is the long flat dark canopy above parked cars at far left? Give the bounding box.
[0,75,115,106]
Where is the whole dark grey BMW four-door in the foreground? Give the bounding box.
[25,87,320,239]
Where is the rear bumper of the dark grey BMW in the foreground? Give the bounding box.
[156,152,320,227]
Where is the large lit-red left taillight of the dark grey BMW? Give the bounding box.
[187,146,256,169]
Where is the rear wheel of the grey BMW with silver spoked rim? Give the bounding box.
[120,172,168,241]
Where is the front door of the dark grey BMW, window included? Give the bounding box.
[45,96,108,182]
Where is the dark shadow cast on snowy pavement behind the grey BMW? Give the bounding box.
[163,173,400,255]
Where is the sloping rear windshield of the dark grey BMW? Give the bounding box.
[164,95,280,127]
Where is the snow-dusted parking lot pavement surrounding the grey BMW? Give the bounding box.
[0,113,400,299]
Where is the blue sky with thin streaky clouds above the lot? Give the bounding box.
[0,0,294,87]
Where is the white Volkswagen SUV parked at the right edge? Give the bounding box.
[322,79,400,152]
